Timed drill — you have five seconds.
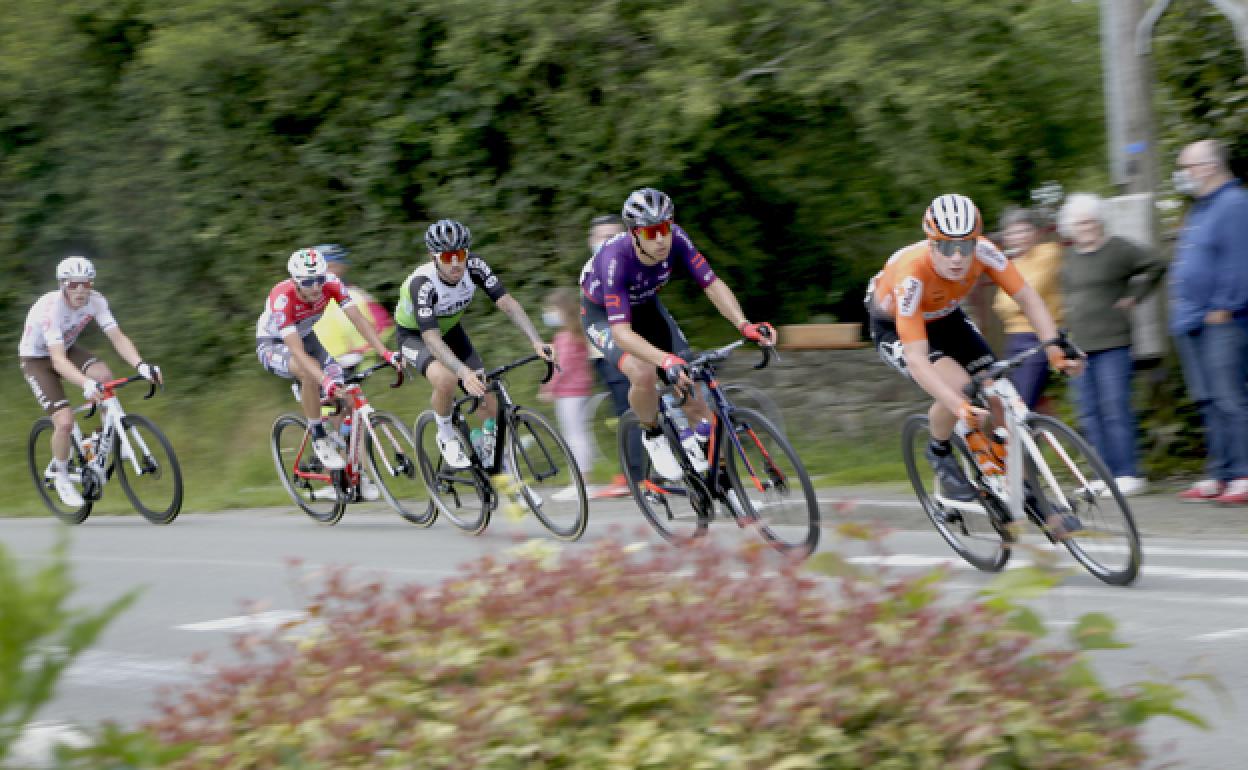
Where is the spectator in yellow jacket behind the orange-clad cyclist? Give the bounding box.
[992,208,1062,409]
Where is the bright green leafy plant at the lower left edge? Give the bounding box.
[0,538,136,763]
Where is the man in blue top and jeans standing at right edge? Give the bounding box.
[1169,140,1248,504]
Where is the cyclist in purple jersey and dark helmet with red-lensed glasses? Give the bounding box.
[580,187,775,479]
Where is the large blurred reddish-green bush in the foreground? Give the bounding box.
[87,543,1194,770]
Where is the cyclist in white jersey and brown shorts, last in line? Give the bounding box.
[17,257,163,508]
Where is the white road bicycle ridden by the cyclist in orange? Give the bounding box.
[901,334,1141,585]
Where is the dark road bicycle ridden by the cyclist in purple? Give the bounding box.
[617,339,820,558]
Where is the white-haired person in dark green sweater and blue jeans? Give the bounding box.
[1057,193,1166,494]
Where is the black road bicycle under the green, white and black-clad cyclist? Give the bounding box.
[414,354,589,540]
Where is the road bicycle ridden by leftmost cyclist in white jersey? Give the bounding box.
[27,374,182,524]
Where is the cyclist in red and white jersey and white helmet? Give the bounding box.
[256,248,403,470]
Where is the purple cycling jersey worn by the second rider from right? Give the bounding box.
[580,225,715,323]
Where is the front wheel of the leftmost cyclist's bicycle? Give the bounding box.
[114,414,182,524]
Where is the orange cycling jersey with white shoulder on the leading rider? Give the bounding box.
[870,238,1027,344]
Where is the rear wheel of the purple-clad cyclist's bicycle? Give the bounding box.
[617,409,710,545]
